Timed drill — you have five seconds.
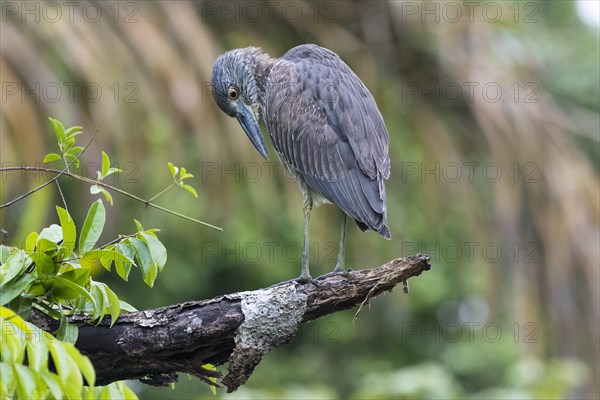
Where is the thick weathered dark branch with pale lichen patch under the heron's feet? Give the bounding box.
[32,254,430,391]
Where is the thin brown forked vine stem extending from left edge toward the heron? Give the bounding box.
[0,166,223,232]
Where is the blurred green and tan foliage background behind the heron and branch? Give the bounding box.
[0,1,600,399]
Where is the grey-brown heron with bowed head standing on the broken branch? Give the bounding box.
[211,44,391,283]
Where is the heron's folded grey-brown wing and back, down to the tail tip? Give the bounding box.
[265,45,390,236]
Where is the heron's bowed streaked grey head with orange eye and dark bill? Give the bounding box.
[211,47,272,159]
